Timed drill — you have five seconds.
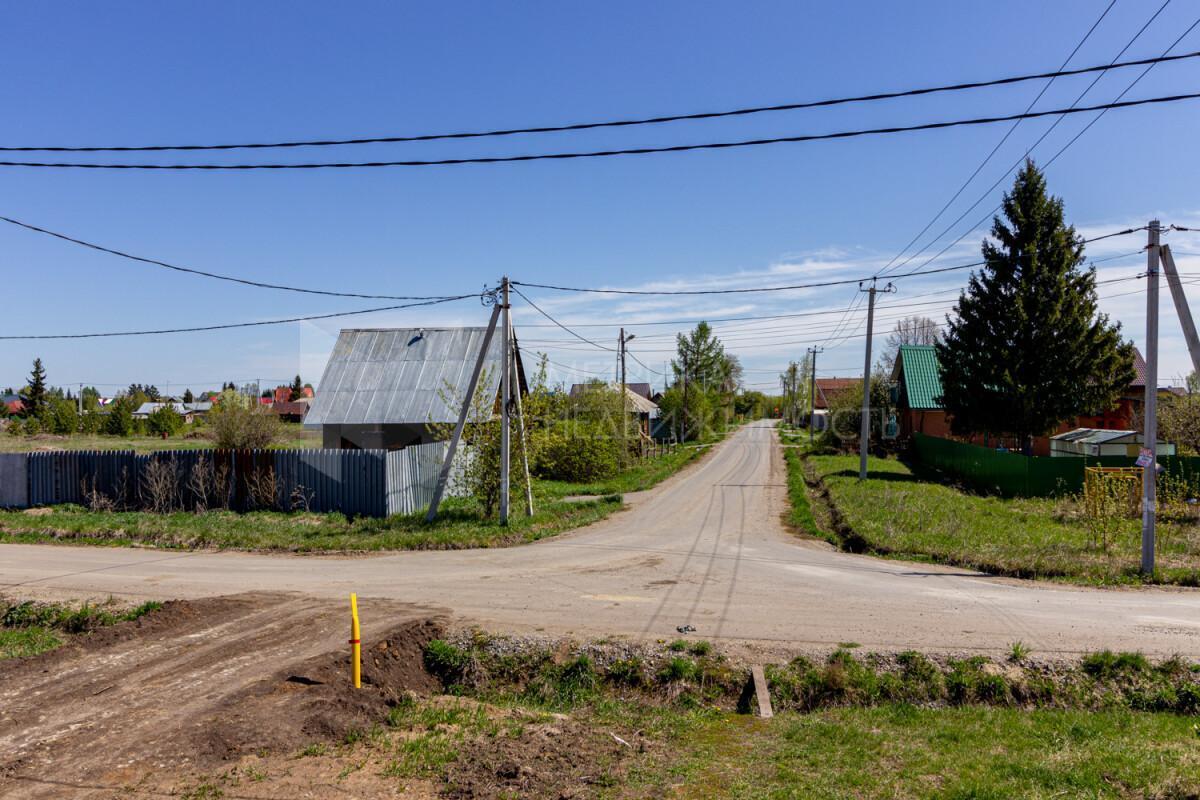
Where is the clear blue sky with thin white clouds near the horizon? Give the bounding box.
[0,0,1200,398]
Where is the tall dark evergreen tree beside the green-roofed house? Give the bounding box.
[936,161,1134,452]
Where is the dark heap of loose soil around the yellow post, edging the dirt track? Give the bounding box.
[188,620,442,764]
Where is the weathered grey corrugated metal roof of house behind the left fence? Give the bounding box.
[305,327,508,428]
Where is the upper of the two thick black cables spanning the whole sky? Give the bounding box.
[0,50,1200,152]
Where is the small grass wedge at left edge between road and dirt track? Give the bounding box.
[0,599,162,660]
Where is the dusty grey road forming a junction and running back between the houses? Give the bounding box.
[0,422,1200,656]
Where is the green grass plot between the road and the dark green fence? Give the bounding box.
[788,456,1200,587]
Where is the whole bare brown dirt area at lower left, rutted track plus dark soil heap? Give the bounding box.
[0,593,439,799]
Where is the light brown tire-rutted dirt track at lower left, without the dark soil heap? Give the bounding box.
[0,593,444,798]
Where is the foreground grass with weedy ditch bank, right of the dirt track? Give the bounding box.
[410,632,1200,800]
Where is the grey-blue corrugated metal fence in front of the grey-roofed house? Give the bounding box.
[0,441,468,517]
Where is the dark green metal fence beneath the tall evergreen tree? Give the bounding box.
[913,433,1200,497]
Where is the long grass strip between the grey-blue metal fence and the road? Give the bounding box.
[0,447,703,553]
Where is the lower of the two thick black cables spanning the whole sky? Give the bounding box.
[0,91,1200,172]
